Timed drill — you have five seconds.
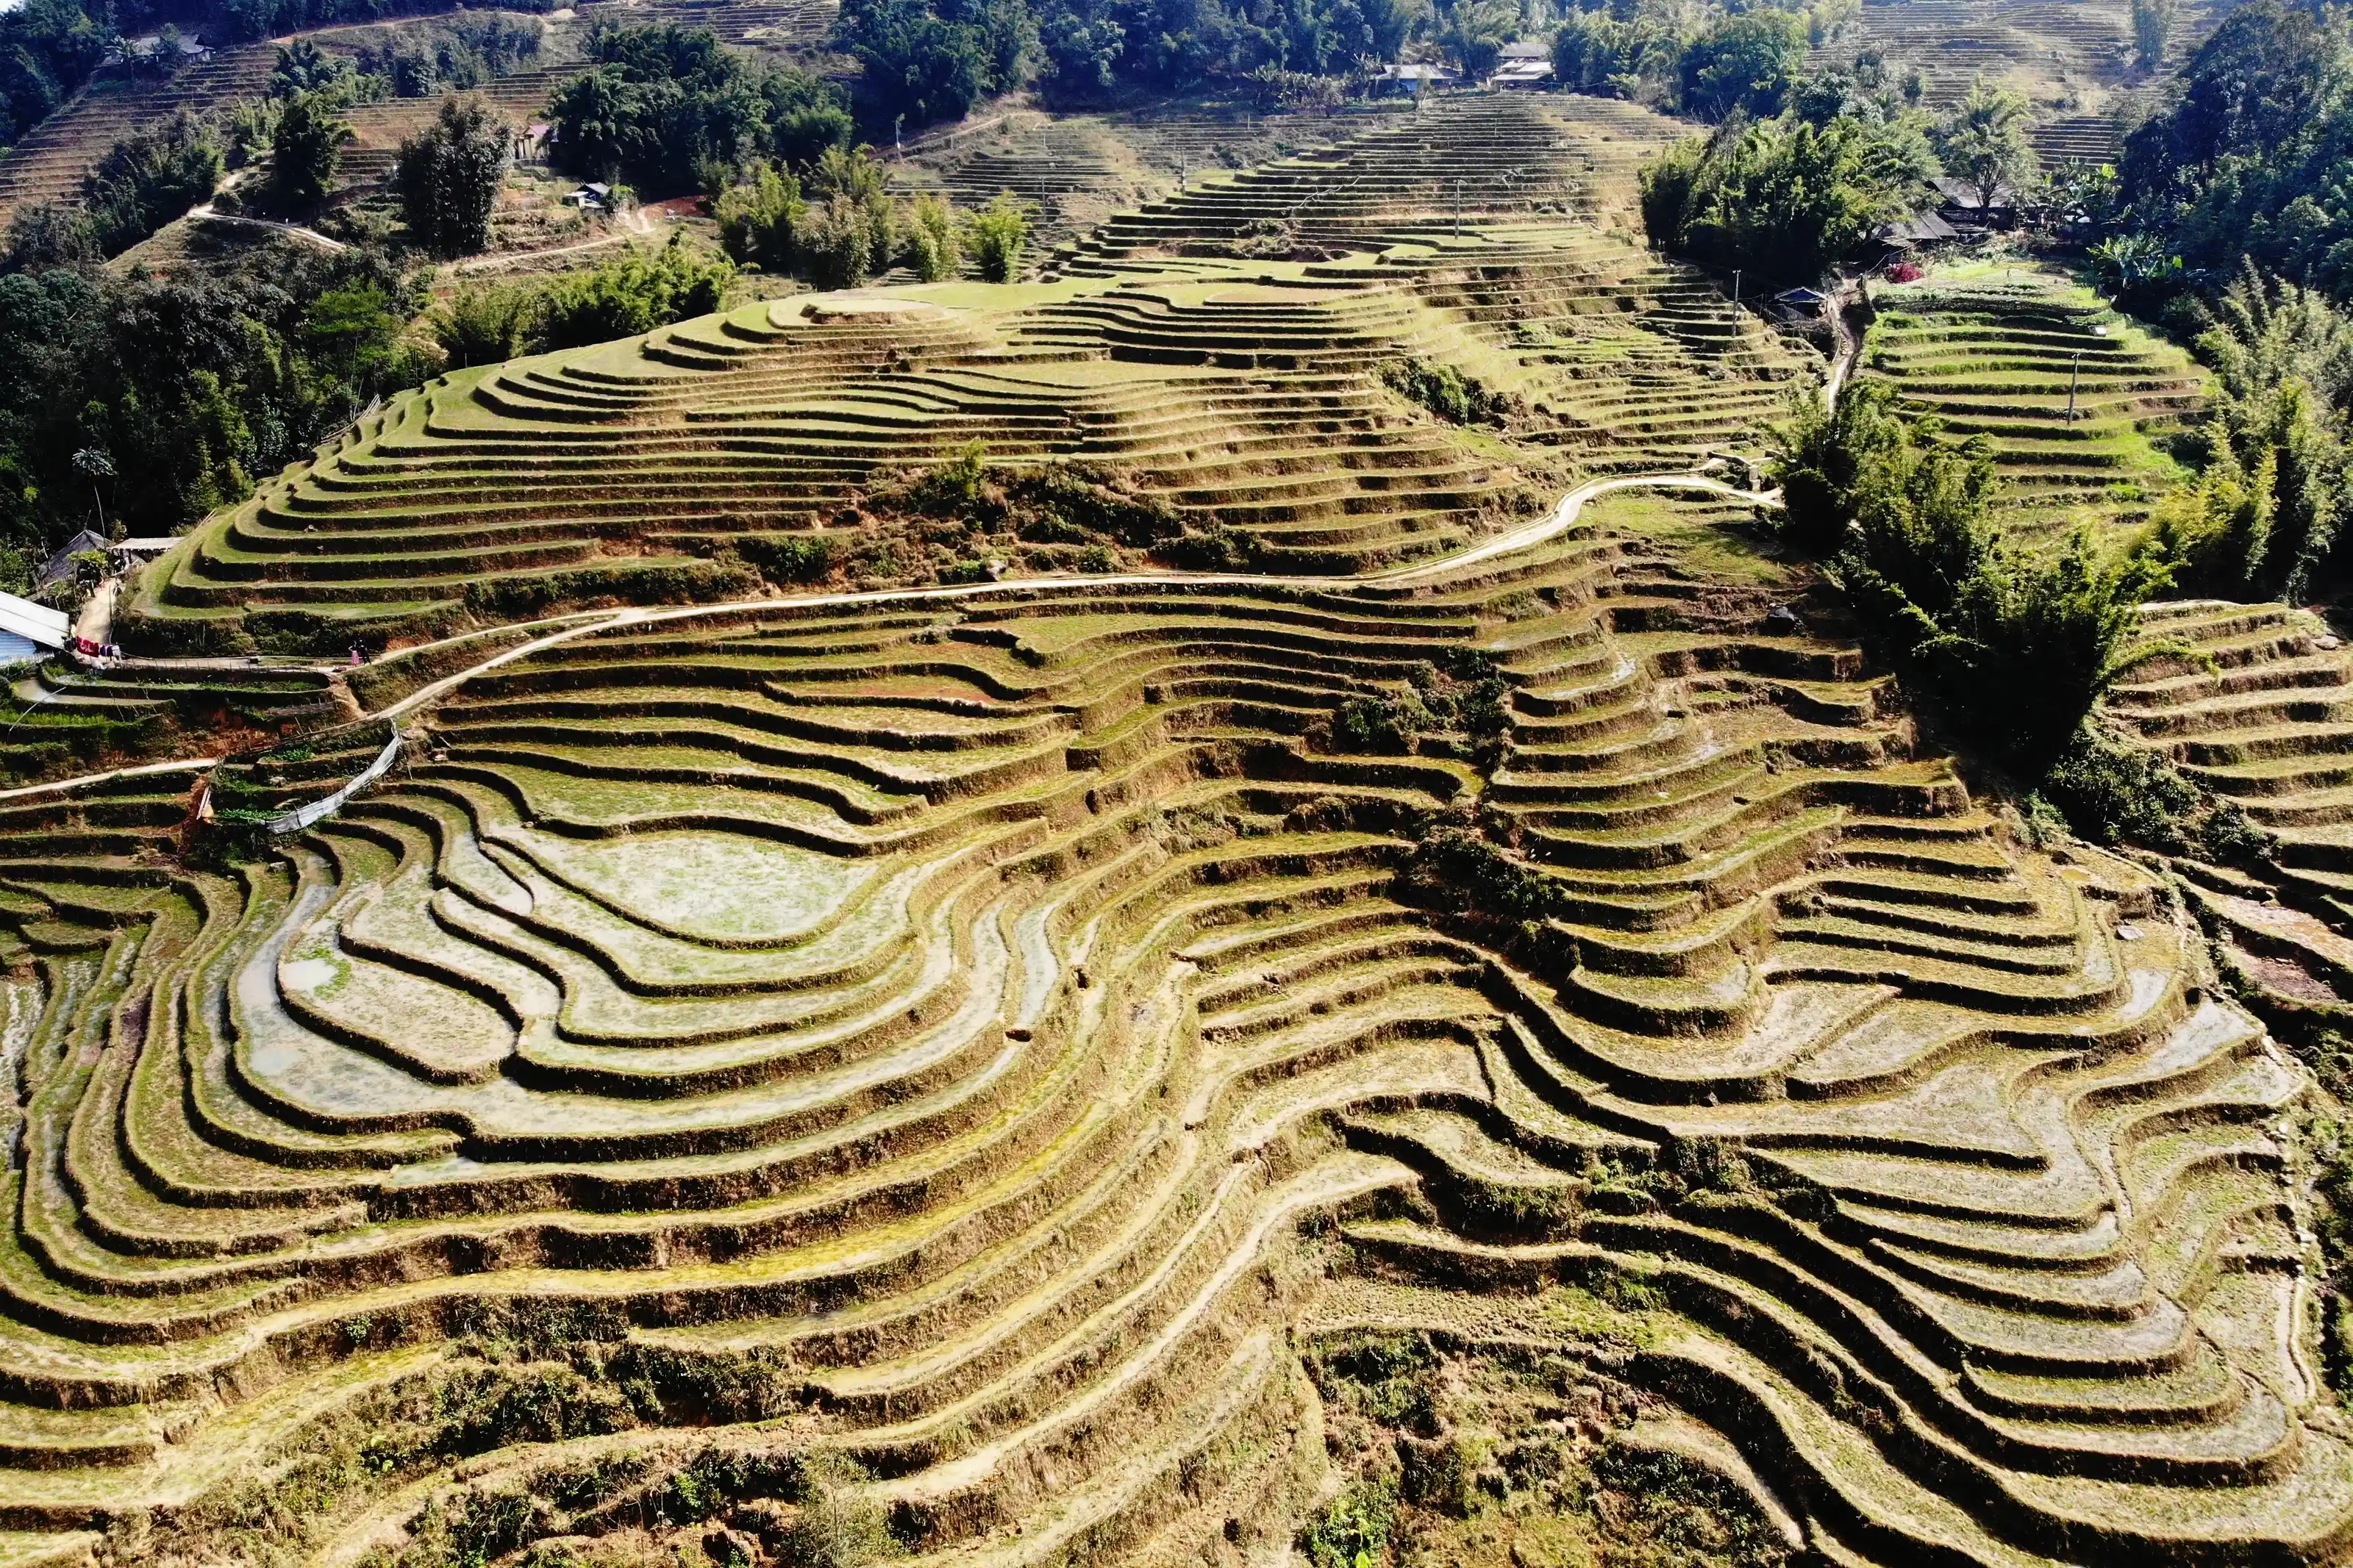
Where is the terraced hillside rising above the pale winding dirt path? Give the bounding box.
[118,99,1812,649]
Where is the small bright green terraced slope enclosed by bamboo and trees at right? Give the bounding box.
[1863,263,2204,534]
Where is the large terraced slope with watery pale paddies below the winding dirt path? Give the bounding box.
[0,446,2353,1564]
